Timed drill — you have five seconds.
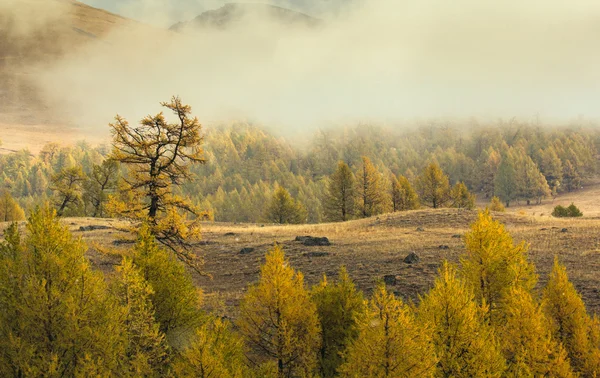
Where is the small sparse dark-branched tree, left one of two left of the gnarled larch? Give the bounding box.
[50,167,85,217]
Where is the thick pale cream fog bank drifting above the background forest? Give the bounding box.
[7,0,600,137]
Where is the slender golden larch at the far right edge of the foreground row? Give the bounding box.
[542,258,600,377]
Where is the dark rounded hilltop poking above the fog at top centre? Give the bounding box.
[170,3,321,32]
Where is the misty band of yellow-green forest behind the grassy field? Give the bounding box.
[0,122,600,223]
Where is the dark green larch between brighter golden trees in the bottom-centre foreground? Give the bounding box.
[311,267,366,377]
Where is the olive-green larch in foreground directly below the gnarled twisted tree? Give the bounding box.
[133,225,202,350]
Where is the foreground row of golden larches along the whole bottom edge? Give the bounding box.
[0,207,600,378]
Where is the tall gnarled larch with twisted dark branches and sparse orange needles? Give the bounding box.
[110,97,205,271]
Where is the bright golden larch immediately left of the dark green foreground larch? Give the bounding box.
[238,245,321,377]
